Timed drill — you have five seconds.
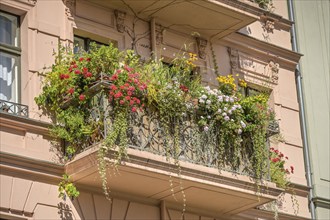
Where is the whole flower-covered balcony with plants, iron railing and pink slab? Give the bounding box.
[36,45,283,217]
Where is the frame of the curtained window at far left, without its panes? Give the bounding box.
[0,10,22,103]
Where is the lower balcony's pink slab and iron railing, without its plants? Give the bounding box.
[62,77,282,217]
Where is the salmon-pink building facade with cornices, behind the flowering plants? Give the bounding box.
[0,0,314,220]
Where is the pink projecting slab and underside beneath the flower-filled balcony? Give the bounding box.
[66,145,282,217]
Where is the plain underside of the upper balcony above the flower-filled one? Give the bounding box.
[86,0,257,38]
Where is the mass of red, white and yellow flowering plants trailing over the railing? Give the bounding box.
[35,45,288,199]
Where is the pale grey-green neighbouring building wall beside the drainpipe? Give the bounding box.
[294,1,330,219]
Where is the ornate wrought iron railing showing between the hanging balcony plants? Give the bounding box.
[62,80,279,179]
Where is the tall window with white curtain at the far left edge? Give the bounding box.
[0,11,21,102]
